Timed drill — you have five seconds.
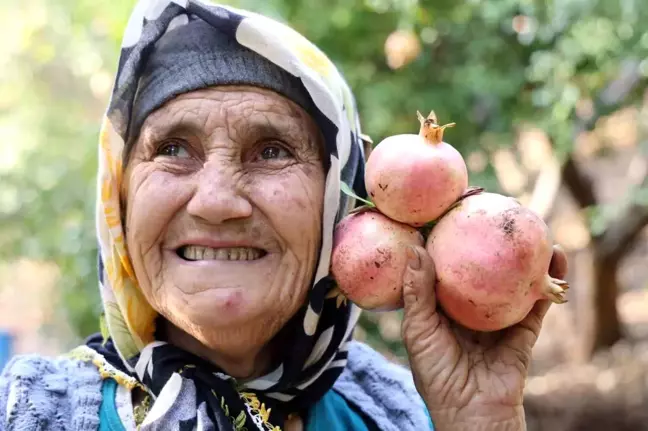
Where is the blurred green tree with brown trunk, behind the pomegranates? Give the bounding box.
[241,0,648,356]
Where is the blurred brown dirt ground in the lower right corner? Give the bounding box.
[525,291,648,431]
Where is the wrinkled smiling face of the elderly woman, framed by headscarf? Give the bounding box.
[124,87,325,354]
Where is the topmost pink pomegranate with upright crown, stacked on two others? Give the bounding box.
[365,111,468,226]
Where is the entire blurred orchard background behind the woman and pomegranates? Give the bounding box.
[0,0,648,431]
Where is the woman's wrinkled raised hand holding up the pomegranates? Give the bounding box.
[402,247,567,431]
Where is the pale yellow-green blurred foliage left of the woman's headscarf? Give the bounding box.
[0,0,131,335]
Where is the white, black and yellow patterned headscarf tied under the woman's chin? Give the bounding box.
[84,0,366,431]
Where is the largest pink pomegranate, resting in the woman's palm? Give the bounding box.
[426,193,569,331]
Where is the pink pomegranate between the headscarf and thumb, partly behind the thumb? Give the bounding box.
[331,210,424,311]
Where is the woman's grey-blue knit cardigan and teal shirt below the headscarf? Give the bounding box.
[0,342,433,431]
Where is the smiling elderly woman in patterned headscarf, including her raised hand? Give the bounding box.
[0,0,565,431]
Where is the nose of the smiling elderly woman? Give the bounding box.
[187,162,252,224]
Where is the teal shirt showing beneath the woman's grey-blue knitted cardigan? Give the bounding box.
[99,379,434,431]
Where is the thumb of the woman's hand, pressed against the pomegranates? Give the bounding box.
[403,246,436,324]
